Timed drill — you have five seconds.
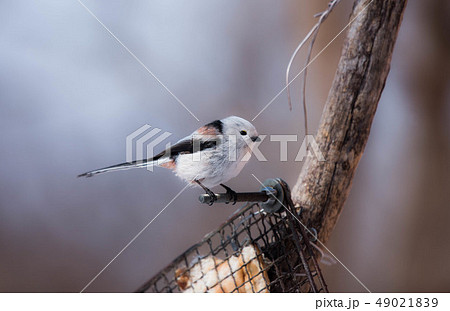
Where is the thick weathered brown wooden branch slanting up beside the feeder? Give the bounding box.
[292,0,407,242]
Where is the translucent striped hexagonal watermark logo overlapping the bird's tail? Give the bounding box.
[126,124,172,171]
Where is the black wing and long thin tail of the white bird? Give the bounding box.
[78,135,220,177]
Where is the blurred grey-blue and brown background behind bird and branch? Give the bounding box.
[0,0,450,292]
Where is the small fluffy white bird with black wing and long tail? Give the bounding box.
[78,116,261,204]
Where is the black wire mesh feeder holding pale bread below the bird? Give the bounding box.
[137,180,327,293]
